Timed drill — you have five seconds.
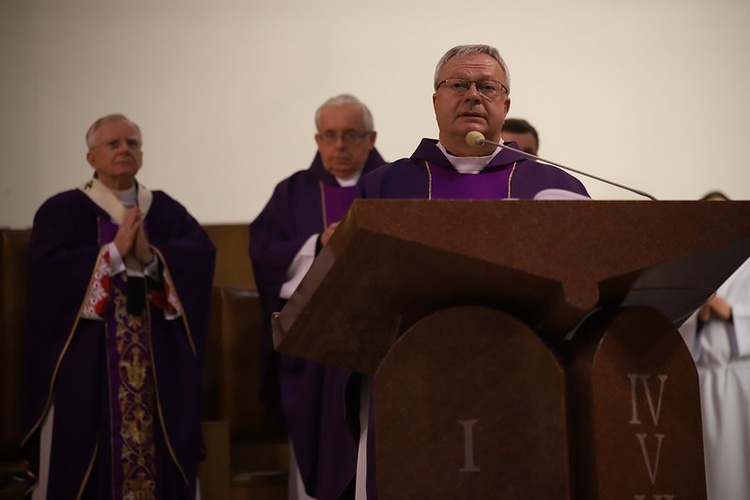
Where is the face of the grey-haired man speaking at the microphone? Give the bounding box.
[432,54,510,155]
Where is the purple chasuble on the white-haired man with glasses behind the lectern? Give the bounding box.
[249,149,384,500]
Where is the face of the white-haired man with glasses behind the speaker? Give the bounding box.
[315,104,376,179]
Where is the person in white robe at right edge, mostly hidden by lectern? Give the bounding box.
[680,191,750,500]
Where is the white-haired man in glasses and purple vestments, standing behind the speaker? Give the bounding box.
[250,94,385,499]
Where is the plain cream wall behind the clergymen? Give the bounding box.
[0,0,750,227]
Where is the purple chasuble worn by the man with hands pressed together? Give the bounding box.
[22,189,216,500]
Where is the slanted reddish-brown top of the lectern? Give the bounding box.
[274,200,750,372]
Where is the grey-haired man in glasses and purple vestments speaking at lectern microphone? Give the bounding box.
[360,45,588,199]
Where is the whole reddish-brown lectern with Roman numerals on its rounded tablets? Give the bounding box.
[274,200,750,500]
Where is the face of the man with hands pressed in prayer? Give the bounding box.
[86,120,143,190]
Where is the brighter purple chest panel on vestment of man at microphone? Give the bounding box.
[425,162,515,200]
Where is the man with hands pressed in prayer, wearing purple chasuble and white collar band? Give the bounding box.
[22,114,215,499]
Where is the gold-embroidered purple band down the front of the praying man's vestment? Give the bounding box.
[99,217,160,500]
